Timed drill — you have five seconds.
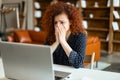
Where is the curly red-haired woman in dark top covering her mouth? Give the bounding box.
[42,2,86,68]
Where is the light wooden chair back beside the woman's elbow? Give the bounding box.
[84,52,95,69]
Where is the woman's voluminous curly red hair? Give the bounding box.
[42,2,86,44]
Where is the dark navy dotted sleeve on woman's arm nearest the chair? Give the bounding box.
[69,34,86,68]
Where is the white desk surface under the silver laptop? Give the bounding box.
[0,59,120,80]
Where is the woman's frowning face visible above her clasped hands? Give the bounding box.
[54,13,70,31]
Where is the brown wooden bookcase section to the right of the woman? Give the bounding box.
[82,0,120,53]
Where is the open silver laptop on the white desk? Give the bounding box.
[0,41,70,80]
